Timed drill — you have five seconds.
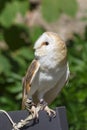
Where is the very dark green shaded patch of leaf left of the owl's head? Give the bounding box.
[4,25,28,51]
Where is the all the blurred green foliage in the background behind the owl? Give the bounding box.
[0,0,87,130]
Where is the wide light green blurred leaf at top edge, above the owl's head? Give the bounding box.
[42,0,78,22]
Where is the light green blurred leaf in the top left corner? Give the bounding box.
[0,0,29,27]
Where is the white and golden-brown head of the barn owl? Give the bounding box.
[34,32,67,65]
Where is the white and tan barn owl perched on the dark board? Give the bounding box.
[22,32,69,119]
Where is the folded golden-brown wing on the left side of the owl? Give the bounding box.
[22,60,40,109]
